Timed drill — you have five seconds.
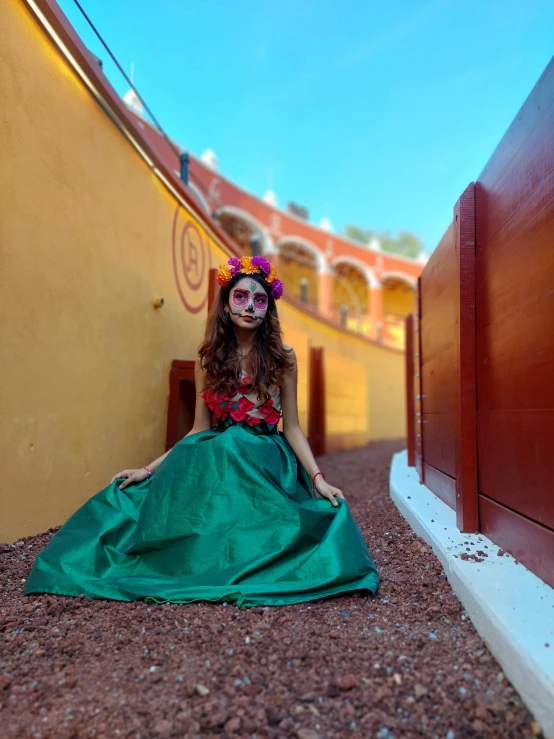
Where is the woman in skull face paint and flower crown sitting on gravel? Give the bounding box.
[24,257,379,607]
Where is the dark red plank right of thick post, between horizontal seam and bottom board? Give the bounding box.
[477,408,554,532]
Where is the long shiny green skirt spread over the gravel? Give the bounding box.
[24,423,379,607]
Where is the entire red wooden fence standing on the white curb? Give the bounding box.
[406,61,554,586]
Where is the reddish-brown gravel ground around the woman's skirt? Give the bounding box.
[0,442,540,739]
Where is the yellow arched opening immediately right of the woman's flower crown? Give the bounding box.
[277,238,320,309]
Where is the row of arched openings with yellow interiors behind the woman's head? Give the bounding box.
[213,211,415,348]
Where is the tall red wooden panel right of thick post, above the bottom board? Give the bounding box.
[476,56,554,544]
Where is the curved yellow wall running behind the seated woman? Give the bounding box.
[0,0,404,541]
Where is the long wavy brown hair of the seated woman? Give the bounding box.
[198,272,294,401]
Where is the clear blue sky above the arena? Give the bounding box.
[59,0,554,251]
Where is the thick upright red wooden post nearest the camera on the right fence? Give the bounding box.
[454,183,479,533]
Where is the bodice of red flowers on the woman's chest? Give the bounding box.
[202,370,281,432]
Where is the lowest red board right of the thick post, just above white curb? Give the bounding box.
[479,495,554,588]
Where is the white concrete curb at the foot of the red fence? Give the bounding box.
[390,450,554,739]
